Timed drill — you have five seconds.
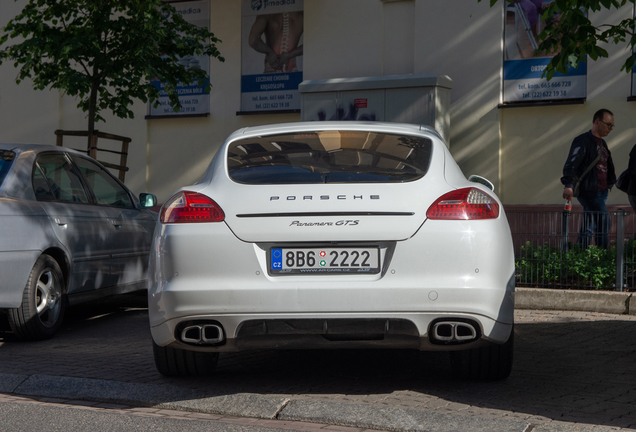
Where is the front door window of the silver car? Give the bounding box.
[73,156,134,208]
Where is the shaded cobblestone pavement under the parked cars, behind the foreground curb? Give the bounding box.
[0,296,636,430]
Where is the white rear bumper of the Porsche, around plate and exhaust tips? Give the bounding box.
[148,219,514,352]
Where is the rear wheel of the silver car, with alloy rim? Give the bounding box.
[8,255,64,340]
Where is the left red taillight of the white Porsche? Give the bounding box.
[159,191,225,223]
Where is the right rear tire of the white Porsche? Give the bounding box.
[451,326,515,381]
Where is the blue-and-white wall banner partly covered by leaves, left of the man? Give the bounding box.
[503,0,587,103]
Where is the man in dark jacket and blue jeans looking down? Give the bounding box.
[561,109,616,248]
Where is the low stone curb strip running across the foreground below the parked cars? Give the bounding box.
[0,374,616,432]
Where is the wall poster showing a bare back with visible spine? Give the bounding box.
[241,0,304,112]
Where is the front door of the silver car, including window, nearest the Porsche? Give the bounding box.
[73,156,155,288]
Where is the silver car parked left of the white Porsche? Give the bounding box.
[0,144,157,340]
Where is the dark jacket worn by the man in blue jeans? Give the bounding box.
[561,131,616,197]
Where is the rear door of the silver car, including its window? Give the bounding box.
[32,152,112,294]
